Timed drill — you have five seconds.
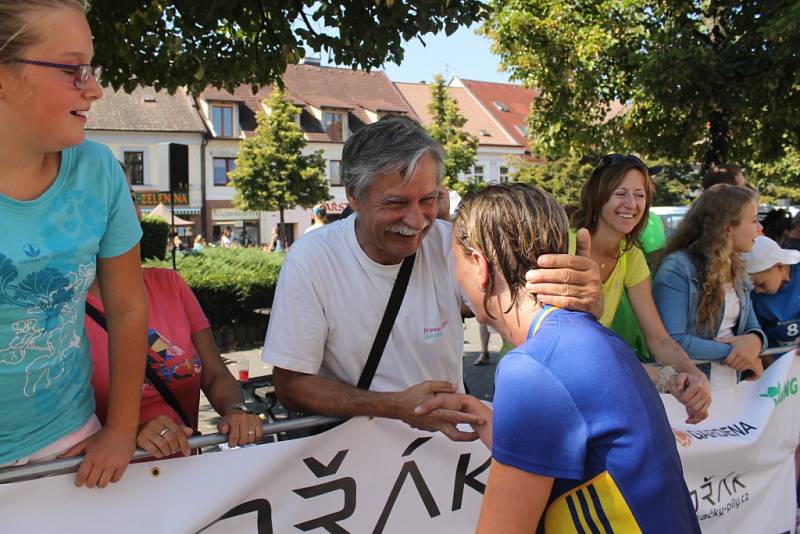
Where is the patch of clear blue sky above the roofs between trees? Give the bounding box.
[314,25,509,82]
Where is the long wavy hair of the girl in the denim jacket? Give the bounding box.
[666,184,756,334]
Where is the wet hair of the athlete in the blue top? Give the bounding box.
[453,184,569,317]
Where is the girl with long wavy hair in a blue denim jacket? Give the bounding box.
[653,184,766,378]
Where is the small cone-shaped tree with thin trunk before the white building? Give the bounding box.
[228,87,331,242]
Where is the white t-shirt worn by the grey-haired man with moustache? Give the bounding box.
[261,216,464,391]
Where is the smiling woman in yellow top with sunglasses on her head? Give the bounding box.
[571,154,711,423]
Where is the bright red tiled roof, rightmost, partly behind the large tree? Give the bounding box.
[460,79,539,150]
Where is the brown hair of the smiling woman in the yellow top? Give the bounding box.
[572,156,653,250]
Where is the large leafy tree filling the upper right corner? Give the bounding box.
[483,0,800,171]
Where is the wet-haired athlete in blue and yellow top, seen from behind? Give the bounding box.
[417,184,700,534]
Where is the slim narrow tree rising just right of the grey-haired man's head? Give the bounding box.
[428,74,486,195]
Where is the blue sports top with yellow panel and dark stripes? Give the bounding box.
[492,308,700,533]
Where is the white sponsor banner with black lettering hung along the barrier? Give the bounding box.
[0,355,800,534]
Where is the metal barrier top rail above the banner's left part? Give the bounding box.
[0,415,343,484]
